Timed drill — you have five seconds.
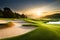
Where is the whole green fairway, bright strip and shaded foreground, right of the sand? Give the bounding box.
[2,19,60,40]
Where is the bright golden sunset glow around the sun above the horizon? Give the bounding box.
[20,8,44,18]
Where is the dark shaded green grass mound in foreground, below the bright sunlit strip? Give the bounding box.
[2,28,60,40]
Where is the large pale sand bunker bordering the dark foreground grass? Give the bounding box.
[0,23,35,39]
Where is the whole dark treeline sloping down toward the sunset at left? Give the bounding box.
[0,7,27,18]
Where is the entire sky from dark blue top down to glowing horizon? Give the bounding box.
[0,0,60,18]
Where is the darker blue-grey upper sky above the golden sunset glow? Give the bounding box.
[0,0,60,11]
